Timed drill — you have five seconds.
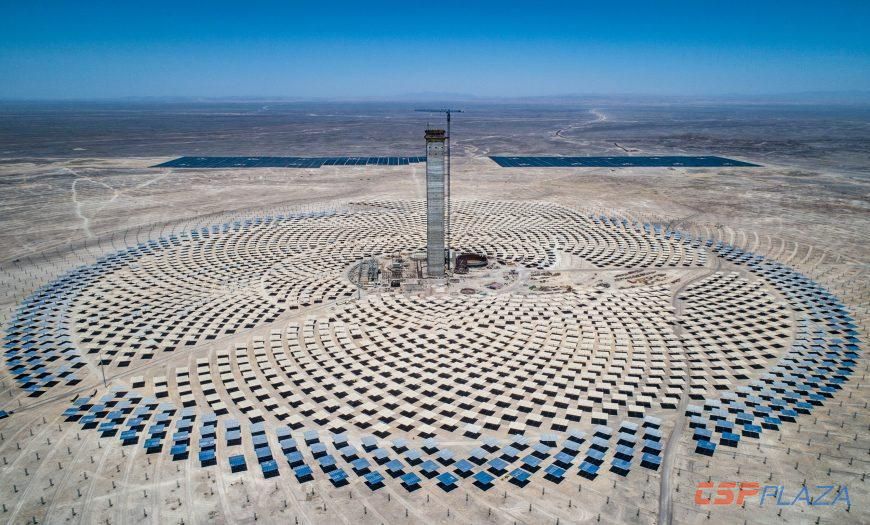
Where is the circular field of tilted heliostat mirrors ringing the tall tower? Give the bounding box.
[5,201,857,504]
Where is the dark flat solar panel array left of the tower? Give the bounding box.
[153,156,426,168]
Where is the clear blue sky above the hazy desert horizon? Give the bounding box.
[0,0,870,98]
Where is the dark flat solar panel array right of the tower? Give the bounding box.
[490,156,758,168]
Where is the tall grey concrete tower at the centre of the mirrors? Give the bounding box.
[426,129,449,279]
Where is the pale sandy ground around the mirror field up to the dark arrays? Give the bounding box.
[0,103,870,523]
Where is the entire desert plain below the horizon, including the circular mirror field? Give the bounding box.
[0,101,870,524]
